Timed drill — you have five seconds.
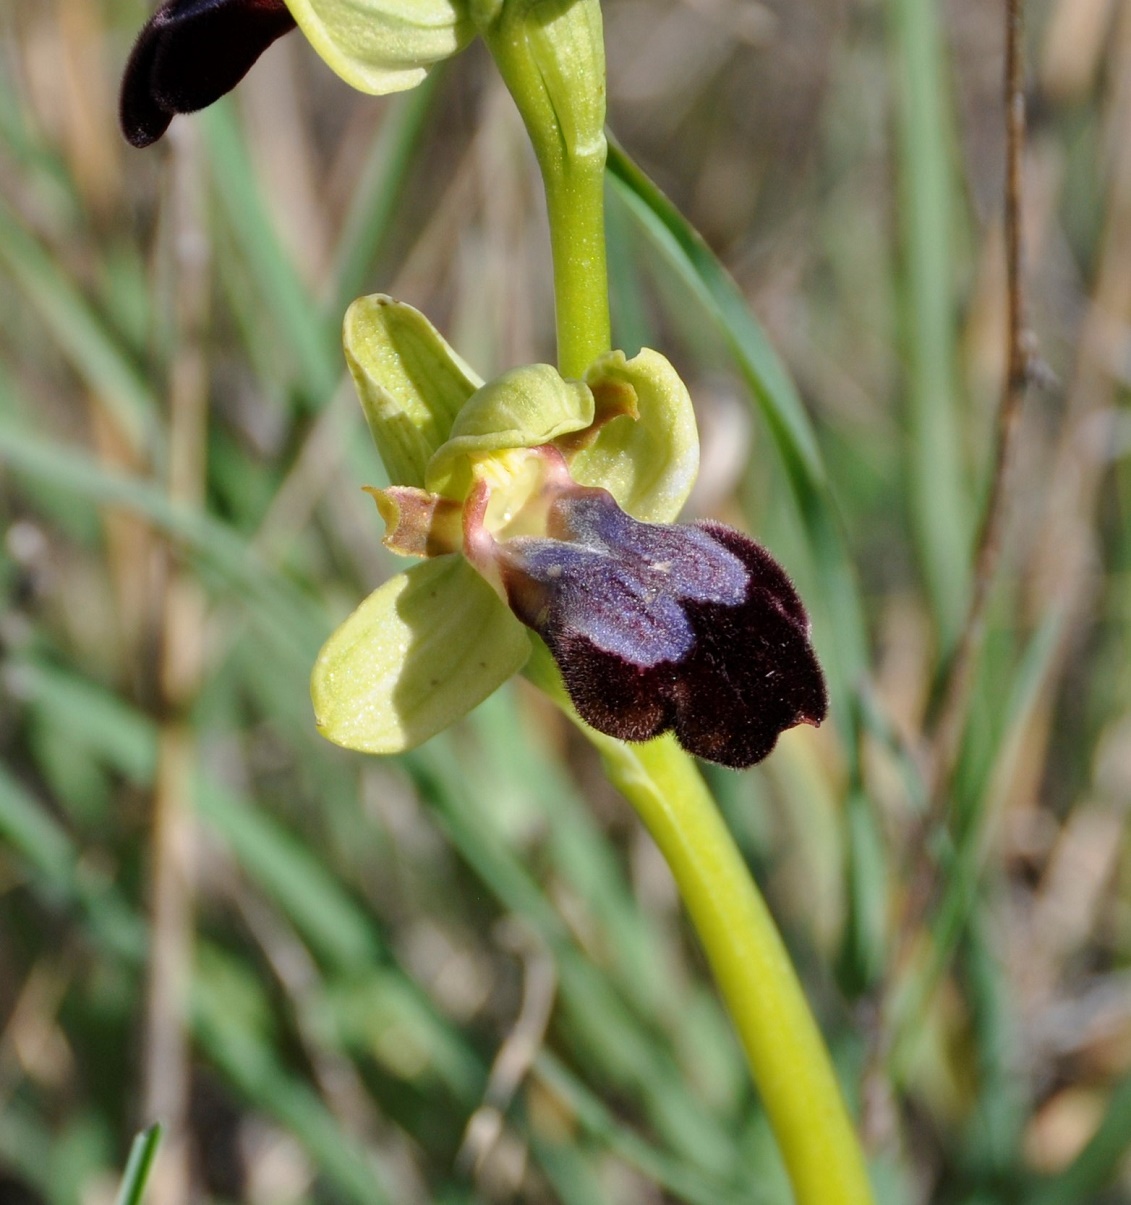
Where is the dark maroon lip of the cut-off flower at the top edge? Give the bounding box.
[118,0,295,147]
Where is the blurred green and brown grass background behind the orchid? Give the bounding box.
[0,0,1131,1205]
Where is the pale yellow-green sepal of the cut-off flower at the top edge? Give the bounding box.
[287,0,476,96]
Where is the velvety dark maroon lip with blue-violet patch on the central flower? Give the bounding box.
[494,487,829,768]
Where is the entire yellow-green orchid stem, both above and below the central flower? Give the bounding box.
[483,0,872,1205]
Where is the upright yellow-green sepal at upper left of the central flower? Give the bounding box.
[342,293,483,488]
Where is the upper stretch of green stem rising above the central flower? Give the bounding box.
[483,0,612,378]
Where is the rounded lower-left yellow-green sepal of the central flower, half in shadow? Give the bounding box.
[311,556,530,753]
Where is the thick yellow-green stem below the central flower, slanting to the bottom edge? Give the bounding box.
[526,641,872,1205]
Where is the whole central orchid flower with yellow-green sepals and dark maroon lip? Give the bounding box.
[312,295,826,766]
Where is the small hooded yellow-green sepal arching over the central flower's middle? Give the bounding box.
[425,364,594,499]
